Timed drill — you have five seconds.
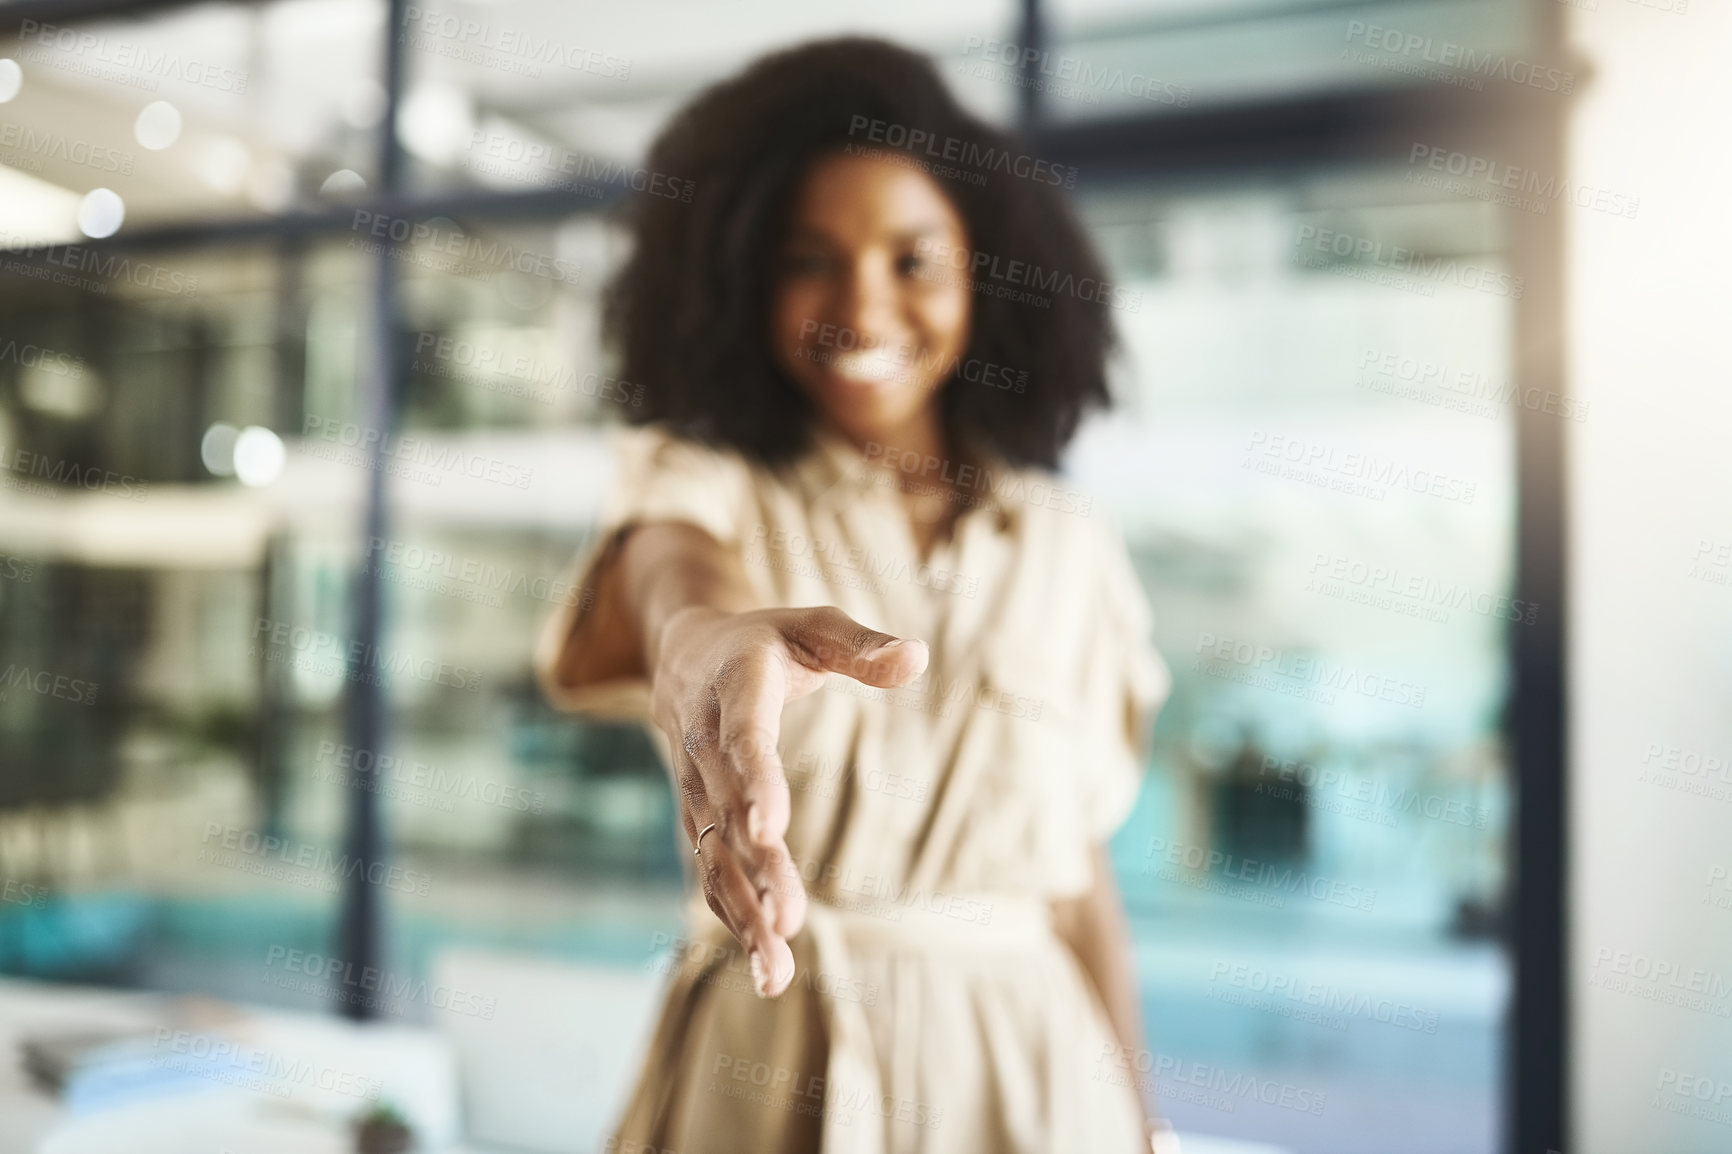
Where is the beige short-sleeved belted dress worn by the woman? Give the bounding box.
[539,428,1171,1154]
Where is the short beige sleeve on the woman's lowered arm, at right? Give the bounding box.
[1083,509,1173,842]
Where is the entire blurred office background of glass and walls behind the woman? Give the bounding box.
[0,0,1732,1154]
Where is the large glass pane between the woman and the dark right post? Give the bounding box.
[1070,166,1524,1152]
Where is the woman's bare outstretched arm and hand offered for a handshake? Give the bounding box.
[535,522,927,996]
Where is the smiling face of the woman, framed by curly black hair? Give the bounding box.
[771,154,970,442]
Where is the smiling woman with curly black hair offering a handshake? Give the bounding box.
[537,40,1169,1154]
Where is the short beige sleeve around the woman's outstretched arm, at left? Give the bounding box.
[535,426,750,721]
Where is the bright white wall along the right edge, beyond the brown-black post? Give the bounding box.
[1572,0,1732,1154]
